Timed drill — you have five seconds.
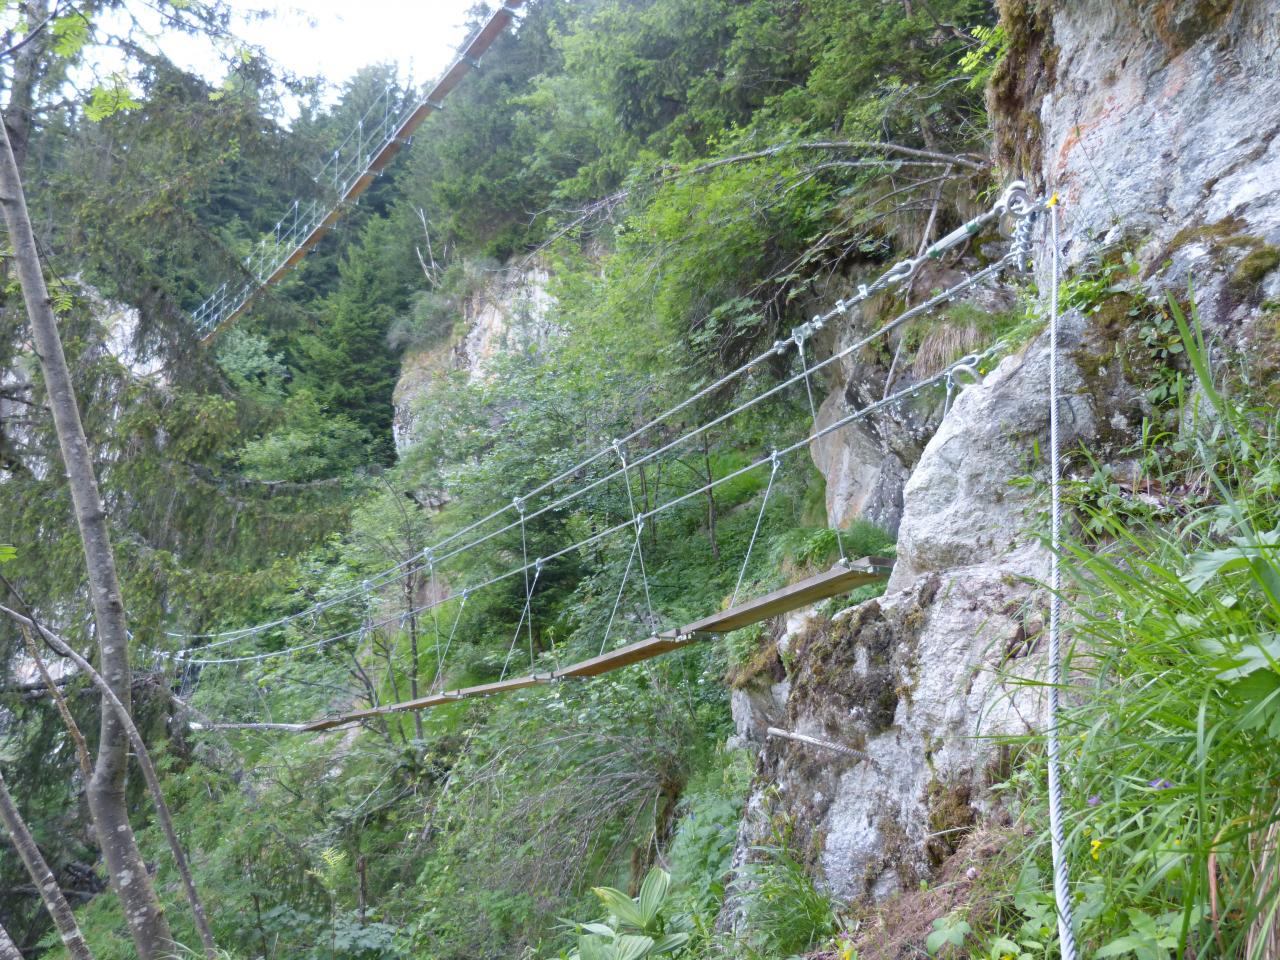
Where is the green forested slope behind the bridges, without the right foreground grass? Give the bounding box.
[0,0,991,960]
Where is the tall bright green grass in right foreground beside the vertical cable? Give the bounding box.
[972,300,1280,960]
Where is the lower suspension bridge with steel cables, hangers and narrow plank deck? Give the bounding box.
[154,183,1046,732]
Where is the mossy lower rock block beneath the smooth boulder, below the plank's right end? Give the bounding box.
[722,564,1043,911]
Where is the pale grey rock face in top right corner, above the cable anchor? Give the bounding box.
[1039,0,1280,268]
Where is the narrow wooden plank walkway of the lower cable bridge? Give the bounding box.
[297,557,893,732]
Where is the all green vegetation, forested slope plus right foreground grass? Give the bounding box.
[0,0,1280,960]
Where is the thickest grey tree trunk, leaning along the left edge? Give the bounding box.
[0,110,174,960]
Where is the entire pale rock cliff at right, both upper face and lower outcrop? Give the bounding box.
[722,0,1280,925]
